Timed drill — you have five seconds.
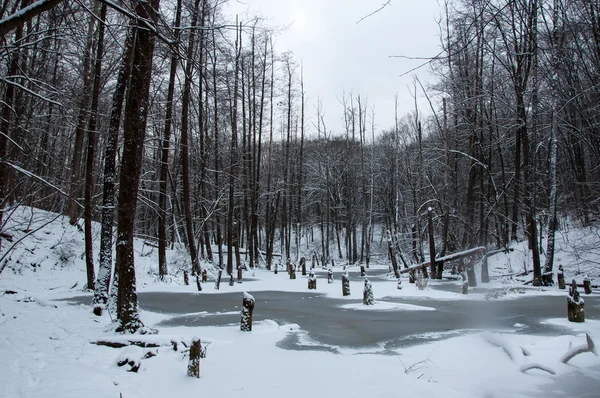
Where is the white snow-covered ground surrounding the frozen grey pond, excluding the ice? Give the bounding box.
[0,209,600,398]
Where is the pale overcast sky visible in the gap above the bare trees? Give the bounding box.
[230,0,442,138]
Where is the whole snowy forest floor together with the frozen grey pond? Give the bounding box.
[0,208,600,398]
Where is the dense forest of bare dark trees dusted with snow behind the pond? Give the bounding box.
[0,0,600,330]
